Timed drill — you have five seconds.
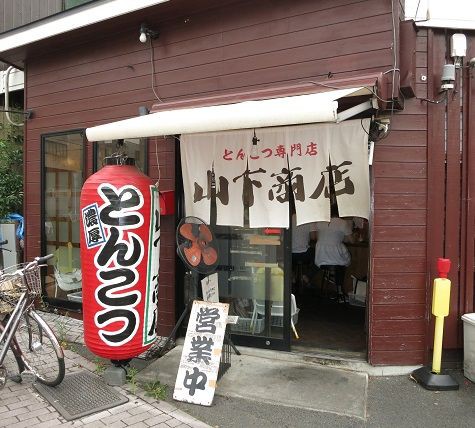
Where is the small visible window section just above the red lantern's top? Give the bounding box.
[94,138,148,174]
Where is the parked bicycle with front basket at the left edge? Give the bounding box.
[0,254,65,389]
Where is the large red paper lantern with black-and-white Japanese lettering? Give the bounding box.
[80,157,160,360]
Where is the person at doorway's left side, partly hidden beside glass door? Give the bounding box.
[292,213,317,290]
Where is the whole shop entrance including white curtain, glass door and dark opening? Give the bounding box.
[179,119,369,358]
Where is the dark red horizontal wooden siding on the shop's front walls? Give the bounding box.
[21,0,436,358]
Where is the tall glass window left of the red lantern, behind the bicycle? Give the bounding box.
[42,131,85,308]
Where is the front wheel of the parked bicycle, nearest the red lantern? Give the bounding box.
[15,310,65,386]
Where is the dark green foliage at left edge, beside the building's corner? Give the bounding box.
[0,125,23,218]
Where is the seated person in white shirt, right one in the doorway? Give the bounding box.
[315,204,353,301]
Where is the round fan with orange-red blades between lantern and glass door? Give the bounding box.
[176,217,218,274]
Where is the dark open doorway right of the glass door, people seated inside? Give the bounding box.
[291,201,369,359]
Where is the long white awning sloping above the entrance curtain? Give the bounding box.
[86,87,372,141]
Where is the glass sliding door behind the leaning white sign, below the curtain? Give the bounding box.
[214,226,290,350]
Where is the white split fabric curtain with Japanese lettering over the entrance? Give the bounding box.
[181,119,369,227]
